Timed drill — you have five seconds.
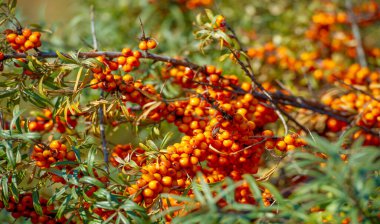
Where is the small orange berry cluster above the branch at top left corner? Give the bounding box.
[6,29,41,53]
